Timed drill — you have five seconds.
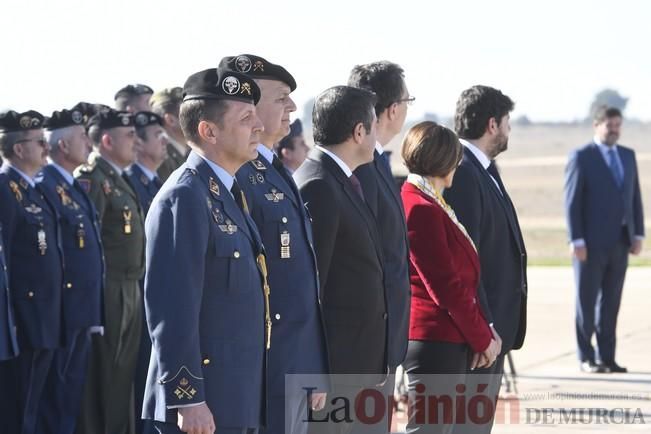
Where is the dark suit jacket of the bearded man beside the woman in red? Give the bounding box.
[445,148,527,353]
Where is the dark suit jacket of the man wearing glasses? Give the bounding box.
[355,152,410,368]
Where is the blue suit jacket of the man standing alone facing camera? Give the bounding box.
[565,143,644,249]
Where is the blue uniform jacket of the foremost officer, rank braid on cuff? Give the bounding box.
[143,152,265,431]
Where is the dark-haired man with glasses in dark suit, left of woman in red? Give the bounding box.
[348,61,414,394]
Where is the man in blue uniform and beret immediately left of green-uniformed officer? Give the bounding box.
[36,110,104,434]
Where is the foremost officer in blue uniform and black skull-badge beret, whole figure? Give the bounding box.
[143,69,272,434]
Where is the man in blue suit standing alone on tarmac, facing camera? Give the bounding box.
[565,106,644,373]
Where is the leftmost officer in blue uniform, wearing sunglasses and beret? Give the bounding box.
[0,110,63,433]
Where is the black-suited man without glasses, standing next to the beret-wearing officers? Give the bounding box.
[294,86,388,433]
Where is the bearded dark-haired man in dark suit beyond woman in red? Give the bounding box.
[445,86,527,432]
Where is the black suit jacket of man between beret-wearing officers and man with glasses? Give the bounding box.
[294,149,388,383]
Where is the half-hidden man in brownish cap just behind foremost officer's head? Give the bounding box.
[149,87,190,181]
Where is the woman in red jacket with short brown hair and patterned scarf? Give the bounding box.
[401,122,499,433]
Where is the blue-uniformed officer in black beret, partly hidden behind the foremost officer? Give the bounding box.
[220,54,327,434]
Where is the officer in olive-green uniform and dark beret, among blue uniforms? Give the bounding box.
[76,110,145,434]
